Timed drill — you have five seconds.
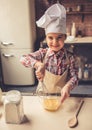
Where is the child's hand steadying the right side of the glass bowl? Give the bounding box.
[61,86,70,103]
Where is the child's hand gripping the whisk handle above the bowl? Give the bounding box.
[35,62,45,81]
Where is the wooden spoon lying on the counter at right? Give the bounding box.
[68,100,84,128]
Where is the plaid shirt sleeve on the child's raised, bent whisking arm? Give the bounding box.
[20,48,47,67]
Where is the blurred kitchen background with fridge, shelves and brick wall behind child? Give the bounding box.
[0,0,92,95]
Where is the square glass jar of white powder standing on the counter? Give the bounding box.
[4,90,24,124]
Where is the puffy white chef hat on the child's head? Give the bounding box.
[36,3,66,34]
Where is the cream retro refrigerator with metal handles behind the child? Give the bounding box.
[0,0,36,85]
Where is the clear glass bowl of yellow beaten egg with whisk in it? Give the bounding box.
[36,82,61,111]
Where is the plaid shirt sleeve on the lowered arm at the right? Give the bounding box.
[67,55,78,89]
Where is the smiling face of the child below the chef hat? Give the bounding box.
[46,33,66,52]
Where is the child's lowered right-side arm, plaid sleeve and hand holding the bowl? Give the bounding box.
[61,56,78,102]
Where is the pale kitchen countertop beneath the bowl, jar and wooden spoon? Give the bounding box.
[0,96,92,130]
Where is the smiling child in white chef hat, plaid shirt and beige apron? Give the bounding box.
[20,3,78,102]
